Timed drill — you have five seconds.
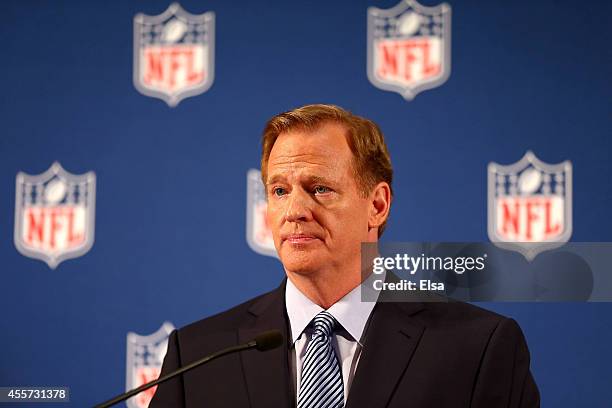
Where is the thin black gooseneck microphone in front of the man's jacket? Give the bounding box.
[94,330,283,408]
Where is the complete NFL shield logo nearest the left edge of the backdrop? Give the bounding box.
[14,162,96,269]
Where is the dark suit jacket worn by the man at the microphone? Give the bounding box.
[150,283,540,408]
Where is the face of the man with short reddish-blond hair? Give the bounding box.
[266,122,369,274]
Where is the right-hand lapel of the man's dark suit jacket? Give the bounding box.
[346,302,425,408]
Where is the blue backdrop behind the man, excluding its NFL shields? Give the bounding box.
[0,0,612,407]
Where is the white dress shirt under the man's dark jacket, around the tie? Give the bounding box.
[285,279,376,404]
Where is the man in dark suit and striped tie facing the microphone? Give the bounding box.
[150,105,539,408]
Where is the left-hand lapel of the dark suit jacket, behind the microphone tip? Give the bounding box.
[238,283,293,408]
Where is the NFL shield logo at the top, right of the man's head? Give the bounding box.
[368,0,451,100]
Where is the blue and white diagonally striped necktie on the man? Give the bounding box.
[298,311,344,408]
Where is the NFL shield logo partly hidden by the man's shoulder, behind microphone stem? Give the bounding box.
[125,322,174,408]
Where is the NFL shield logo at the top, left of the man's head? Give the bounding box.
[134,3,215,107]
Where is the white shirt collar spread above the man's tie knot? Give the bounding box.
[285,279,376,345]
